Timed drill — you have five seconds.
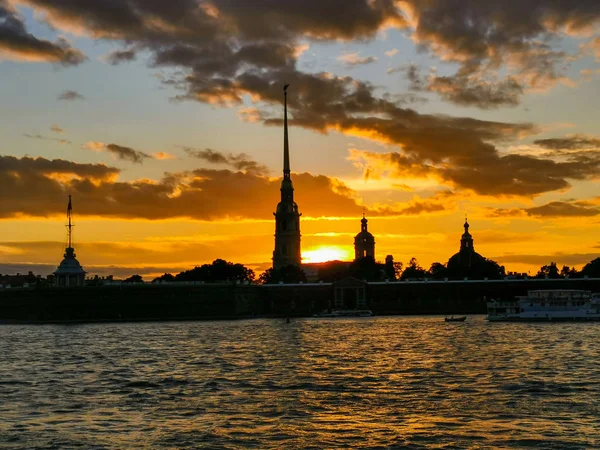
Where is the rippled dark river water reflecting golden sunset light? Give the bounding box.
[0,316,600,449]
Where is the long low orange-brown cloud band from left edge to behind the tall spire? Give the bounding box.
[0,156,408,220]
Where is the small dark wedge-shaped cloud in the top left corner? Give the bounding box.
[0,0,86,66]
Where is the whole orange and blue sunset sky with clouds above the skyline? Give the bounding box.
[0,0,600,279]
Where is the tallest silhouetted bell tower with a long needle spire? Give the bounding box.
[273,84,302,269]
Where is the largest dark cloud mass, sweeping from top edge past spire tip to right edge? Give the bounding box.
[10,0,600,199]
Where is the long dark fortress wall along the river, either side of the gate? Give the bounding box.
[0,279,600,323]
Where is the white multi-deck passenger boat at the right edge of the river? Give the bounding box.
[487,289,600,322]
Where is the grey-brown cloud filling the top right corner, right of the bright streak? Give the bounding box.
[398,0,600,108]
